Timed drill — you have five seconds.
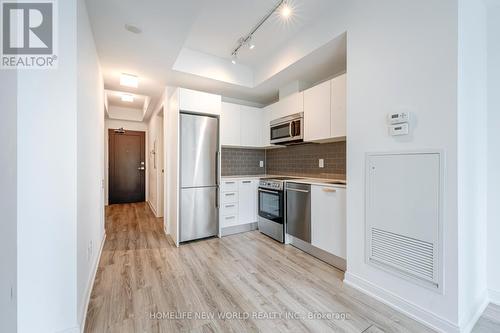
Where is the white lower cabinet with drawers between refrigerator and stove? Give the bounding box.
[219,178,259,228]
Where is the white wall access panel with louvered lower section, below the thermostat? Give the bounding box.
[366,152,443,289]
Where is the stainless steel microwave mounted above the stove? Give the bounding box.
[270,112,304,145]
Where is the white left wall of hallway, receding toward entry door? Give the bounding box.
[77,0,104,326]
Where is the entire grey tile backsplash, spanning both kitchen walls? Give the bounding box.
[221,141,346,179]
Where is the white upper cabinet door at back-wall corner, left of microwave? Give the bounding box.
[240,105,263,147]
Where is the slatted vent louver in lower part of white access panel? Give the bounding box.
[370,228,435,282]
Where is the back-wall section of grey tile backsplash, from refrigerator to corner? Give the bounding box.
[221,148,266,176]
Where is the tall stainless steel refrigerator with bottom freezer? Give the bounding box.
[179,113,219,242]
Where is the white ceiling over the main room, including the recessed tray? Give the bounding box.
[86,0,345,118]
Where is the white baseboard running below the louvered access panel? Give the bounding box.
[344,272,461,333]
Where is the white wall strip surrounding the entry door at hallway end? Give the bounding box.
[104,119,149,205]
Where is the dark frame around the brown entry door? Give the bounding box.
[107,128,149,204]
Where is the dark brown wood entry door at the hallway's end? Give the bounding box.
[109,129,146,204]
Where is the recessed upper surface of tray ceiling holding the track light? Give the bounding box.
[184,0,331,68]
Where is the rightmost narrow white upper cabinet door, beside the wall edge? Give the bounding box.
[331,74,347,138]
